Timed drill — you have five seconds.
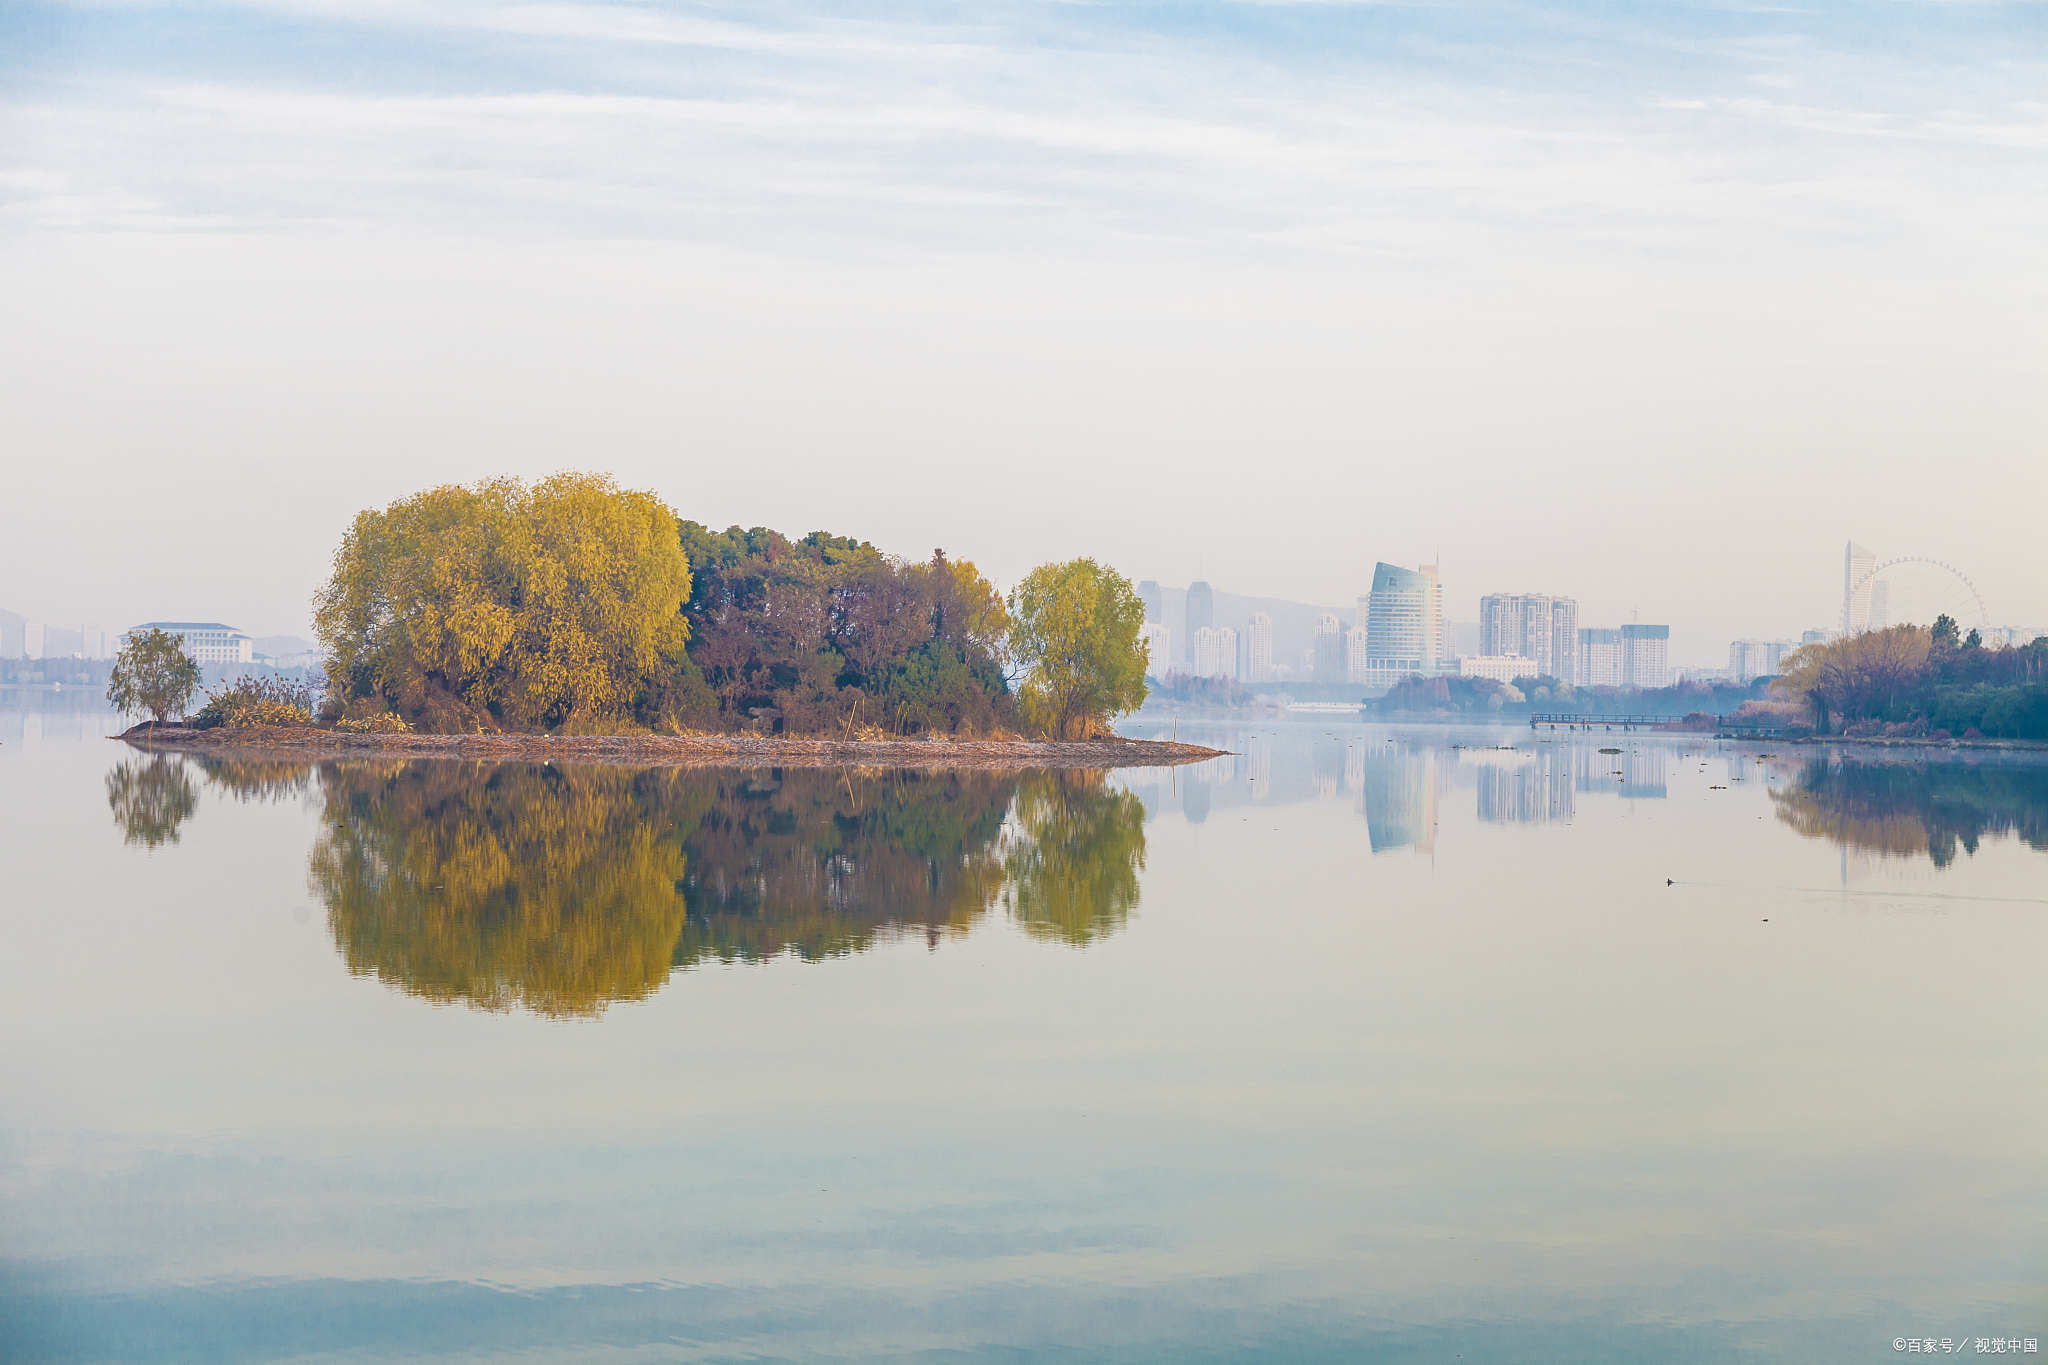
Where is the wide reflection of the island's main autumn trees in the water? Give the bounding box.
[288,759,1145,1015]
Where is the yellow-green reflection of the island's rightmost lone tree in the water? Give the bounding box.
[1006,772,1145,945]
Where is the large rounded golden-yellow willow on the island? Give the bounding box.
[313,473,690,731]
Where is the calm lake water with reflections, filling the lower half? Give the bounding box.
[0,694,2048,1365]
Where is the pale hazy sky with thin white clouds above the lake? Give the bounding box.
[0,0,2048,663]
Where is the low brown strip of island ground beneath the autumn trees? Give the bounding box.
[115,726,1227,769]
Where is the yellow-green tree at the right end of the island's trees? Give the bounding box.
[1010,559,1145,739]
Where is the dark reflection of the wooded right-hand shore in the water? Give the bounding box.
[1772,757,2048,868]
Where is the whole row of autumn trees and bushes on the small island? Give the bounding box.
[109,473,1145,739]
